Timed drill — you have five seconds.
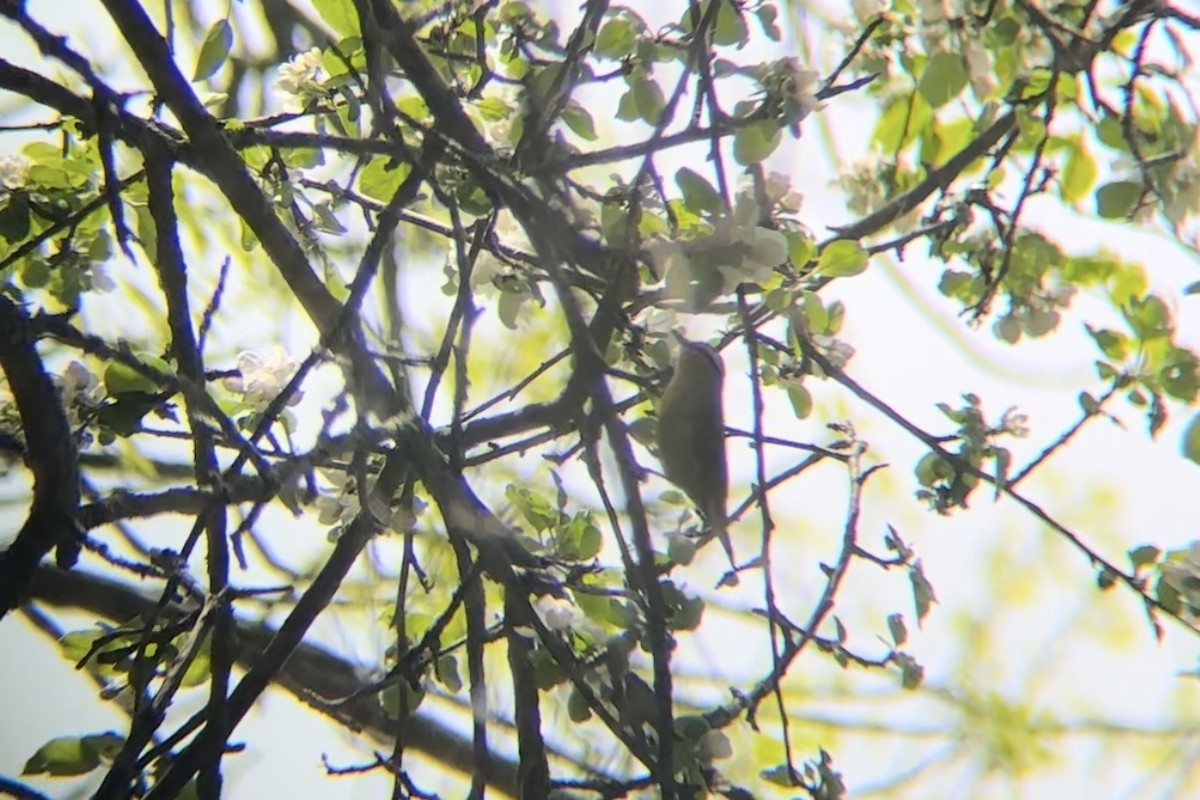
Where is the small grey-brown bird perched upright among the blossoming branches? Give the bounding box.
[658,333,737,570]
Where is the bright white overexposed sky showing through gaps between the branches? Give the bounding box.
[0,0,1200,798]
